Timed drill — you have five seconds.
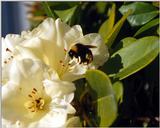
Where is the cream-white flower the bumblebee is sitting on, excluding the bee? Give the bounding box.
[16,18,109,81]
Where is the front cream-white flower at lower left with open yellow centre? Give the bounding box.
[2,59,75,128]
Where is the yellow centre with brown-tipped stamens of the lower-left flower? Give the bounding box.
[25,88,45,112]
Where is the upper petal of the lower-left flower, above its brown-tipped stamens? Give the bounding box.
[9,59,47,90]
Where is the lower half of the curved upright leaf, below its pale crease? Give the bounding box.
[97,95,117,127]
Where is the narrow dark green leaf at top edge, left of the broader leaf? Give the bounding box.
[41,2,56,19]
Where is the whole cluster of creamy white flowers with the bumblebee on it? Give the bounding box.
[1,18,109,128]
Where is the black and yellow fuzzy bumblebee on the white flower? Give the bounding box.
[68,43,96,65]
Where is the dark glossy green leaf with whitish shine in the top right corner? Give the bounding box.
[119,2,159,26]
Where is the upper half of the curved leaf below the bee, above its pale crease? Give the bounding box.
[86,70,114,99]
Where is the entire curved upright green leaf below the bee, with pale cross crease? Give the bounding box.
[86,70,117,127]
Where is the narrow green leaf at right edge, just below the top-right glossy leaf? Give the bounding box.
[134,18,159,36]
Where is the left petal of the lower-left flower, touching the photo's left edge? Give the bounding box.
[2,83,31,125]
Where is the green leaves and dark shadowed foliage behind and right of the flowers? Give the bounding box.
[28,2,160,127]
